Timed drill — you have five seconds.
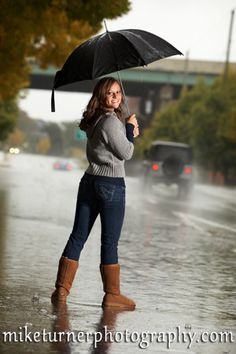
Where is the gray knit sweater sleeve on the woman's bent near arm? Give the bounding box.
[101,114,134,160]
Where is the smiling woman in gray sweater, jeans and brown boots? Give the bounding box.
[51,77,139,309]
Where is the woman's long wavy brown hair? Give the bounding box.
[79,77,124,130]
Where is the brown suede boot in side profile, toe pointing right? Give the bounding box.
[100,264,136,310]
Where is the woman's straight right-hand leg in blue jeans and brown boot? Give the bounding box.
[96,183,135,310]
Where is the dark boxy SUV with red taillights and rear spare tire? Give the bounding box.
[143,140,193,197]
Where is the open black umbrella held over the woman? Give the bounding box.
[51,29,182,112]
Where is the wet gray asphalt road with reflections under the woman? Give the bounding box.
[0,154,236,354]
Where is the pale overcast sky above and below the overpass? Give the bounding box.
[20,0,236,121]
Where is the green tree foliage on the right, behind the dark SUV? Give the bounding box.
[139,72,236,181]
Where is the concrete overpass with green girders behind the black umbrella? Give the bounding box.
[30,59,236,126]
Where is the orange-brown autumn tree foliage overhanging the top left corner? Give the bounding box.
[0,0,130,139]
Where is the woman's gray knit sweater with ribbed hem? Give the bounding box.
[86,112,134,177]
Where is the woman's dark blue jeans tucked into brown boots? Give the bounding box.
[62,173,125,264]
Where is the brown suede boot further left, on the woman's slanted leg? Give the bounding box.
[51,257,79,304]
